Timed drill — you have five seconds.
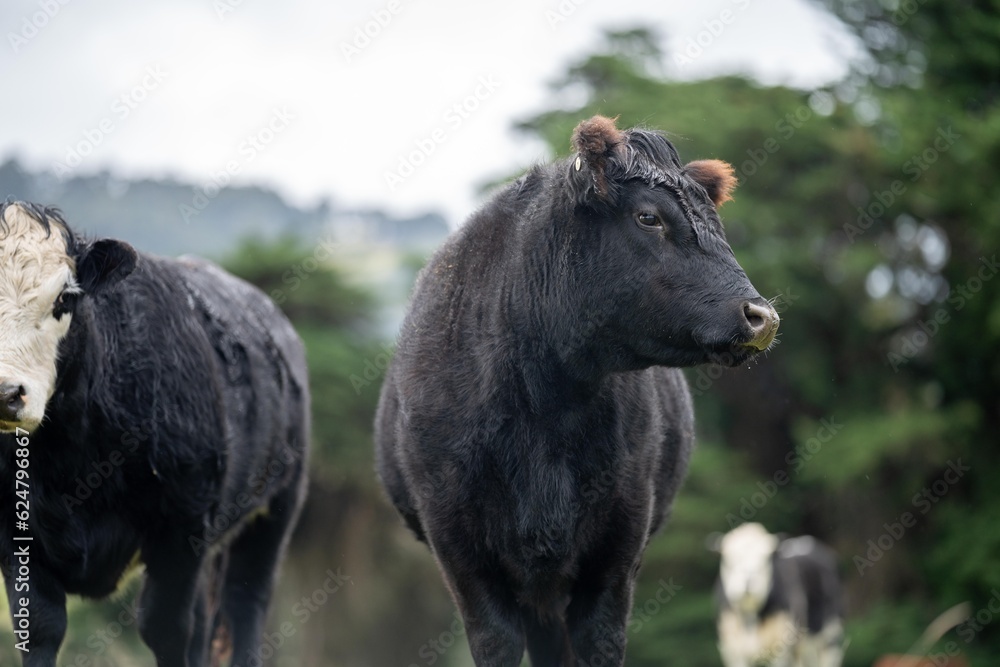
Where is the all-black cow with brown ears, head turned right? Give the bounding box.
[376,117,778,667]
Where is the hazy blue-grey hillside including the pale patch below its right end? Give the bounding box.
[0,158,449,339]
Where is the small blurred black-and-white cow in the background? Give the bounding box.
[717,523,843,667]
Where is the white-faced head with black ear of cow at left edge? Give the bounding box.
[0,201,136,433]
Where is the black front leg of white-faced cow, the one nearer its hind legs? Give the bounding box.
[139,534,202,667]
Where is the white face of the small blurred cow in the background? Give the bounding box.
[719,523,778,614]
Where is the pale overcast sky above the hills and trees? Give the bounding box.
[0,0,856,224]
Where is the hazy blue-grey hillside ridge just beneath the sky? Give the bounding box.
[0,158,448,257]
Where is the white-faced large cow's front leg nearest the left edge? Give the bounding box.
[3,564,66,667]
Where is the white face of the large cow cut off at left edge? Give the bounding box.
[0,205,79,432]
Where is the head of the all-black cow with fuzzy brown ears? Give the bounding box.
[565,116,778,367]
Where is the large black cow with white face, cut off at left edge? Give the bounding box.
[0,202,309,667]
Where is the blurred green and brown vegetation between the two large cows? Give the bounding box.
[224,238,461,667]
